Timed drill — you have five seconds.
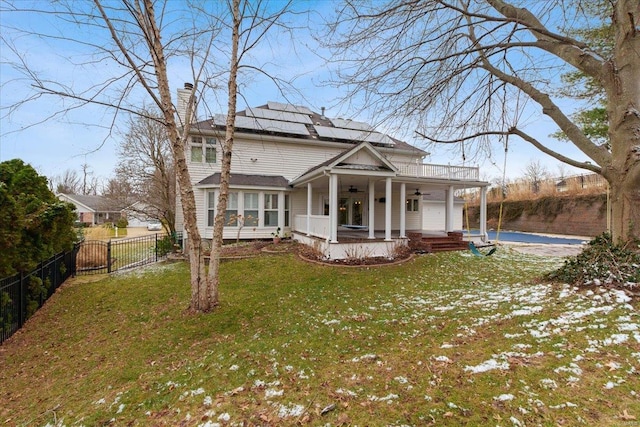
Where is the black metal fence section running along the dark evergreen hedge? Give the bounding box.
[0,246,78,344]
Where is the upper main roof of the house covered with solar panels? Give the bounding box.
[192,102,428,156]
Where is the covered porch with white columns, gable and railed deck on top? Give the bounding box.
[291,143,488,259]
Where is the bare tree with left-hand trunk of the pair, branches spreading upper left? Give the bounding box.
[1,0,288,312]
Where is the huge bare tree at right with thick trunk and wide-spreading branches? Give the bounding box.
[328,0,640,244]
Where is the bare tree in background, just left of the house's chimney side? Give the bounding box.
[114,109,176,233]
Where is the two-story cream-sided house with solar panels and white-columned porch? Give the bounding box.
[176,85,489,259]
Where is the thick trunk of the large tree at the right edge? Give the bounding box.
[602,0,640,241]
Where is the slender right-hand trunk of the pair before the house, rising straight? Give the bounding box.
[207,0,241,308]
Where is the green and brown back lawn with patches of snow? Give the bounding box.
[0,248,640,426]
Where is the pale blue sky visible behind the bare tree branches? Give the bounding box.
[0,1,587,189]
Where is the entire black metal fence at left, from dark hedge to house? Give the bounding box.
[0,233,182,344]
